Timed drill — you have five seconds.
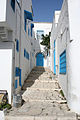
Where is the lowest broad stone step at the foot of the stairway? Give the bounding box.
[5,101,70,117]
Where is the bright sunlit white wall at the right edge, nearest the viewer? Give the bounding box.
[68,0,80,114]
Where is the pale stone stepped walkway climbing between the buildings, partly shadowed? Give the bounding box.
[5,67,77,120]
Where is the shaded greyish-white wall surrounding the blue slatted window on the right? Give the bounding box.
[51,0,70,99]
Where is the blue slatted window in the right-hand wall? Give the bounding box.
[60,50,66,74]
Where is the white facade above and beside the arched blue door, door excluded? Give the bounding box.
[34,22,52,67]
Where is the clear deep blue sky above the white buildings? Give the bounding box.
[32,0,63,22]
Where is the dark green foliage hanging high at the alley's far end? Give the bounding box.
[40,33,50,50]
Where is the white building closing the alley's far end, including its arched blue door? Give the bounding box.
[34,22,52,67]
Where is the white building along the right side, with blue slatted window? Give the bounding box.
[51,0,80,113]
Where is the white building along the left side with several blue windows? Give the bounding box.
[0,0,36,103]
